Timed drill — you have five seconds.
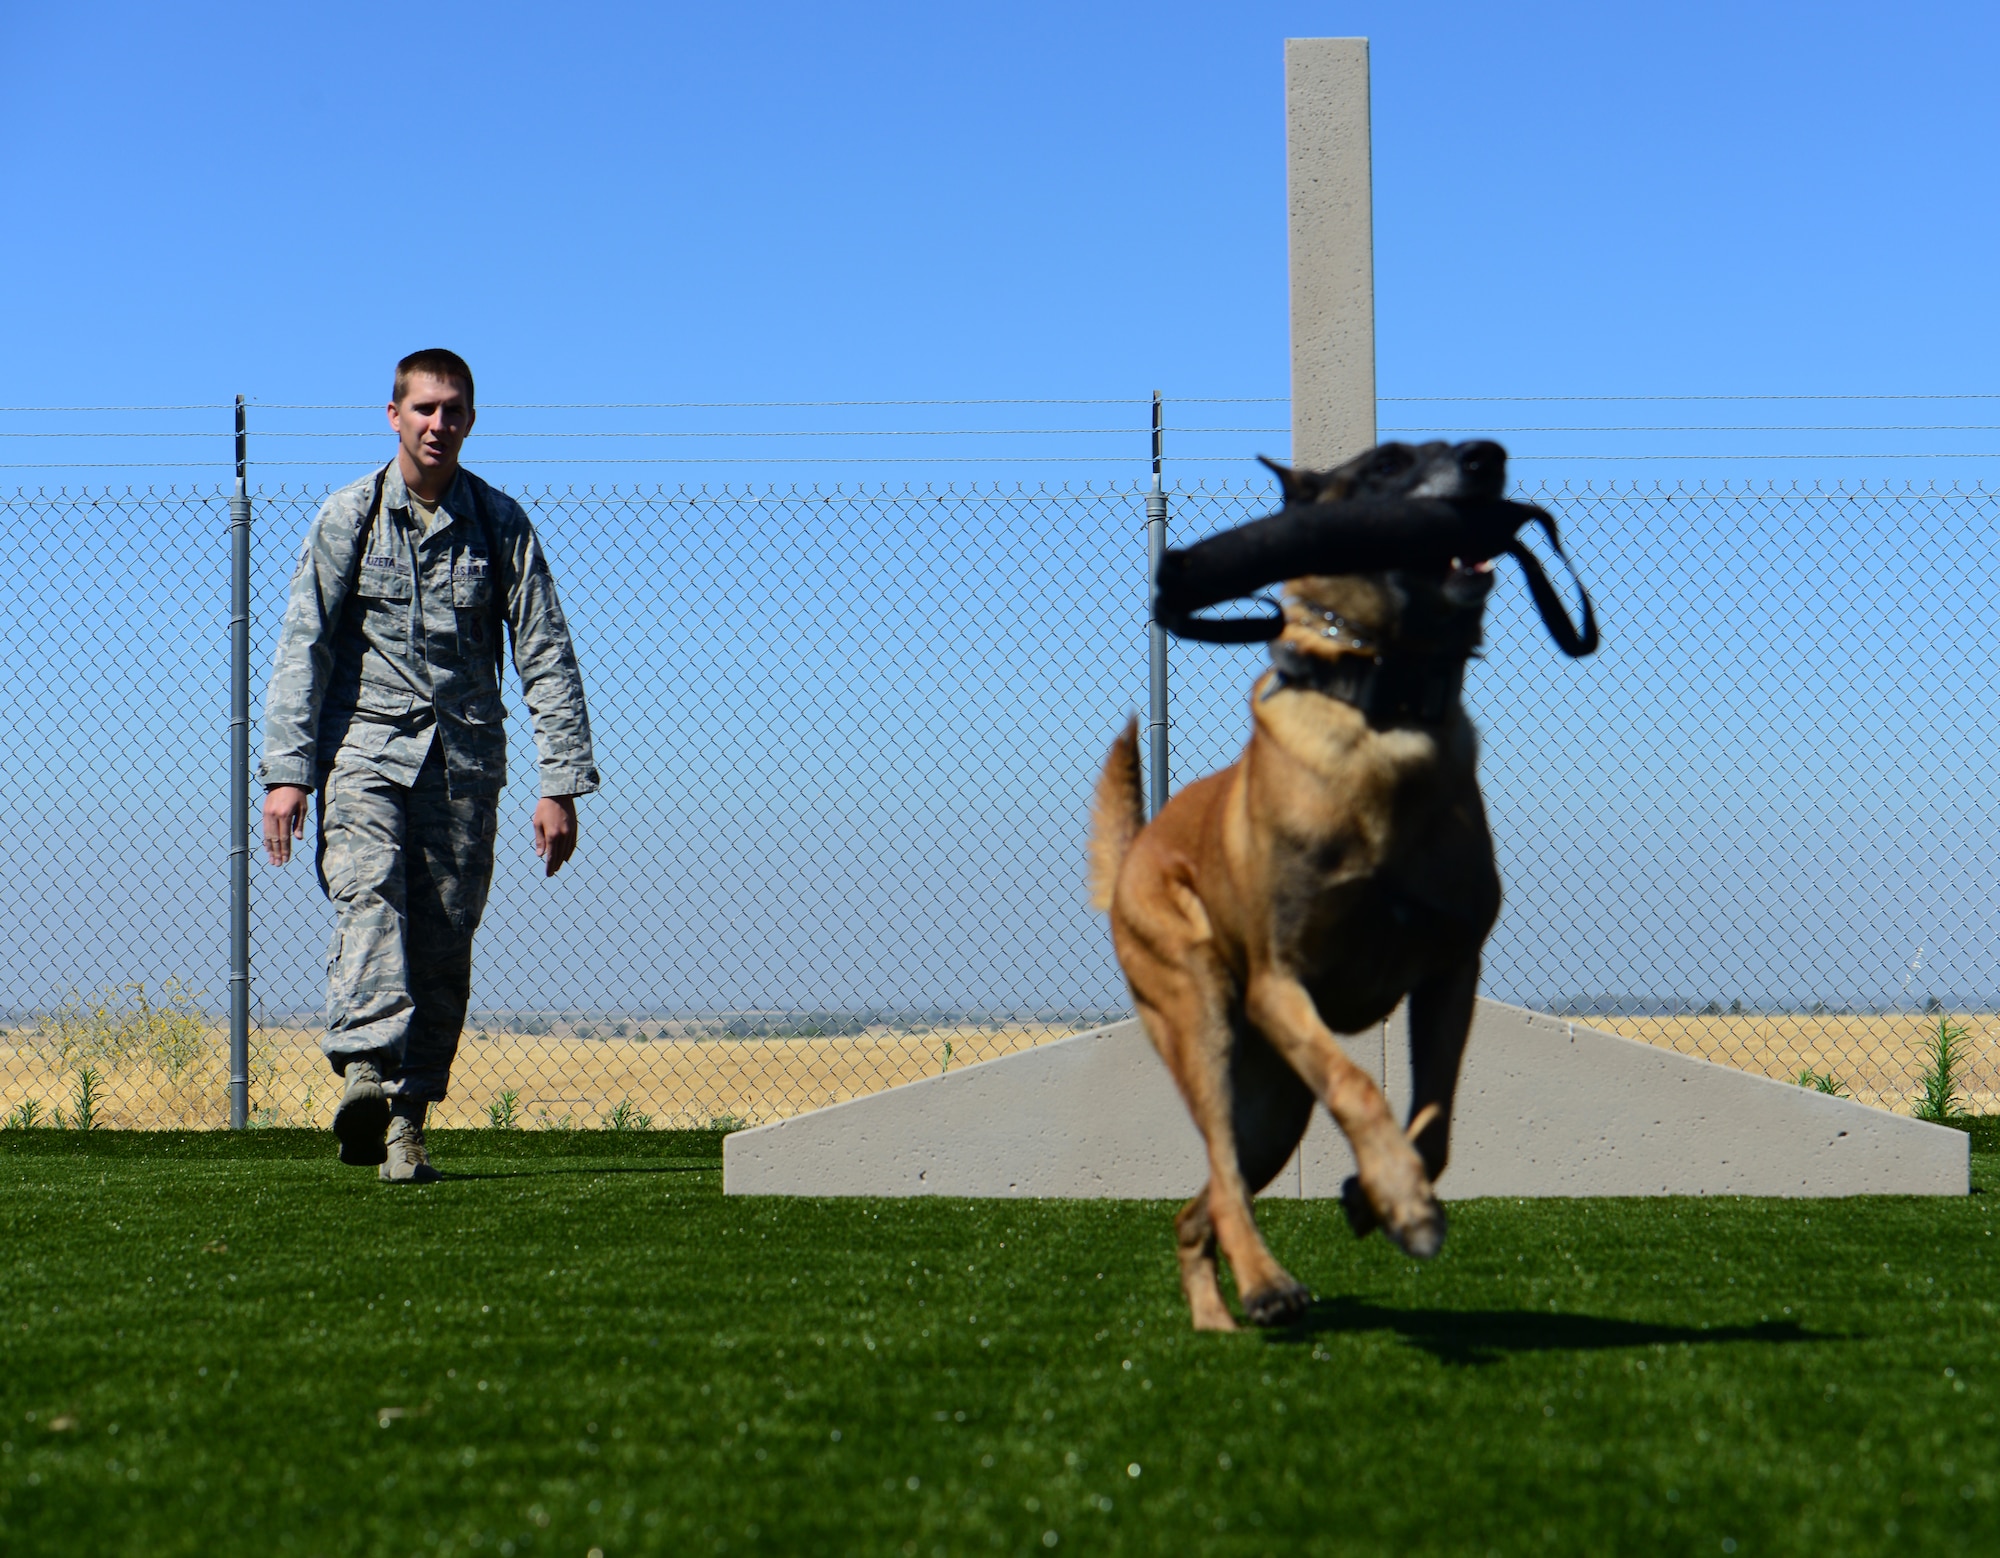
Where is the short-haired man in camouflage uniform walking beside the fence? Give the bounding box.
[260,350,598,1184]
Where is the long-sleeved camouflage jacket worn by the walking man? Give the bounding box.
[258,464,598,796]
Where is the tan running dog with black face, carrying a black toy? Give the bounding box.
[1090,444,1596,1330]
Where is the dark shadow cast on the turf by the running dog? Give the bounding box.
[1268,1298,1834,1364]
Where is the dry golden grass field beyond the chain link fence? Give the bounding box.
[0,1014,2000,1130]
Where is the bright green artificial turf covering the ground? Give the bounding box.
[0,1132,2000,1558]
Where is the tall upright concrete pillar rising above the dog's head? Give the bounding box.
[1284,38,1376,470]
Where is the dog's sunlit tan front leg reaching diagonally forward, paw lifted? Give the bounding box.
[1224,968,1444,1260]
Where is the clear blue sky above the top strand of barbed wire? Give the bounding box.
[0,0,2000,420]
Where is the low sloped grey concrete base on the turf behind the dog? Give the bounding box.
[722,1000,1970,1200]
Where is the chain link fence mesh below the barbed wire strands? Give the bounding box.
[0,484,2000,1128]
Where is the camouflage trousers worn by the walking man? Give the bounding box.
[318,744,498,1104]
